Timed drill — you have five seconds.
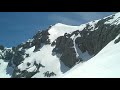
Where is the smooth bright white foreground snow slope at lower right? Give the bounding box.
[60,34,120,78]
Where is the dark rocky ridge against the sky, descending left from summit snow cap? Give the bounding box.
[13,30,50,51]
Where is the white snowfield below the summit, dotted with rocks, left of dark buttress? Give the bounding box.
[18,45,65,78]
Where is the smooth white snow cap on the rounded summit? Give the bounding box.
[48,23,86,42]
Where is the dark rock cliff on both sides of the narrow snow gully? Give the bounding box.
[51,15,120,68]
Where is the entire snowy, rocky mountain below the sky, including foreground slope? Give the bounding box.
[0,13,120,78]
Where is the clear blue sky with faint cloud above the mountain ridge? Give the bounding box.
[0,12,114,47]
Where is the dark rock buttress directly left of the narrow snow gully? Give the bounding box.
[52,34,79,68]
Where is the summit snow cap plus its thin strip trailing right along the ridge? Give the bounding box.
[48,19,100,42]
